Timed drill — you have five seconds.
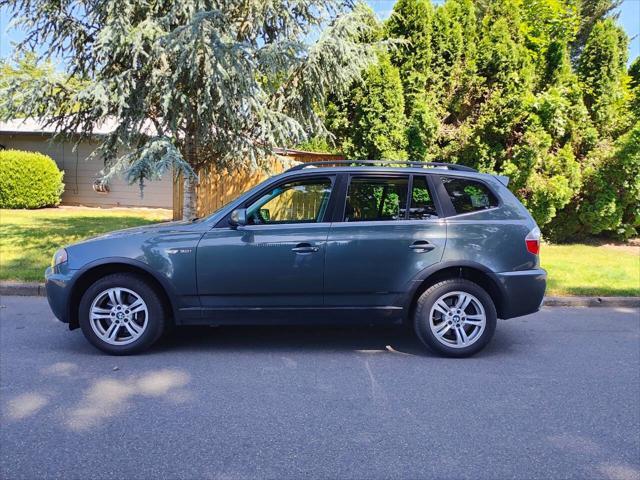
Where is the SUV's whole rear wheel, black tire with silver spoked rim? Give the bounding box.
[414,279,497,357]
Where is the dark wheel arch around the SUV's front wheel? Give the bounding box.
[68,258,176,330]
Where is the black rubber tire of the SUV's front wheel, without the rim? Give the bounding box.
[79,273,167,355]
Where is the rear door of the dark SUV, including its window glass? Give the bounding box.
[324,174,446,309]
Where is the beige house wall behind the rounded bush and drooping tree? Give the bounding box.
[0,132,173,208]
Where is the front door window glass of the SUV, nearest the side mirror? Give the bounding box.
[247,178,331,225]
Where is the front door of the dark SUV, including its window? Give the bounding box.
[197,176,334,316]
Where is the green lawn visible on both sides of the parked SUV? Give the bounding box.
[0,207,640,296]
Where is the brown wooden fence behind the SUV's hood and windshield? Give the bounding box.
[173,150,343,220]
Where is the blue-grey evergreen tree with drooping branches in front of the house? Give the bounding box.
[0,0,375,218]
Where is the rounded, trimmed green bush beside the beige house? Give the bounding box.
[0,150,64,208]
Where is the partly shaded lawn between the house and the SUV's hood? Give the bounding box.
[0,207,171,281]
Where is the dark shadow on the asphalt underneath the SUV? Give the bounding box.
[150,326,512,357]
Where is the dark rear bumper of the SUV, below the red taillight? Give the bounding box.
[495,268,547,319]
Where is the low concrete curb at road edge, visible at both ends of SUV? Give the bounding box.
[0,282,640,308]
